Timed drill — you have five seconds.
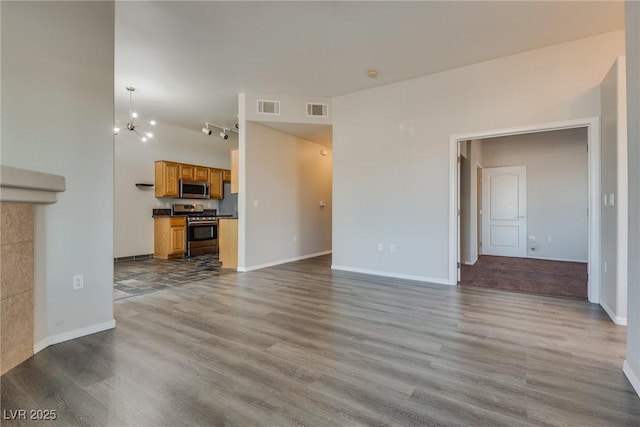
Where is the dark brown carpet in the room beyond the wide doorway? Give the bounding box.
[460,255,587,299]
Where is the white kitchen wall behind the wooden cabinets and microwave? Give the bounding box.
[114,123,238,258]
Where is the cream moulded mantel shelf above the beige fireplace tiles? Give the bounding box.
[0,165,65,204]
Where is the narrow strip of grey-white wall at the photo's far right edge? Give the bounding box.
[624,1,640,402]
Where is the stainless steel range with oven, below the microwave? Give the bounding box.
[172,205,218,256]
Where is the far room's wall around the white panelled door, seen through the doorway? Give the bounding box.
[482,128,589,262]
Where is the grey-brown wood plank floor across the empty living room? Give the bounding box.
[1,256,640,427]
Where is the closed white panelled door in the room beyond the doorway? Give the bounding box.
[482,166,527,258]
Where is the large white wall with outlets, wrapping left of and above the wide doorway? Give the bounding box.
[333,31,624,283]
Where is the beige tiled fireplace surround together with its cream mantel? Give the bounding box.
[0,165,65,375]
